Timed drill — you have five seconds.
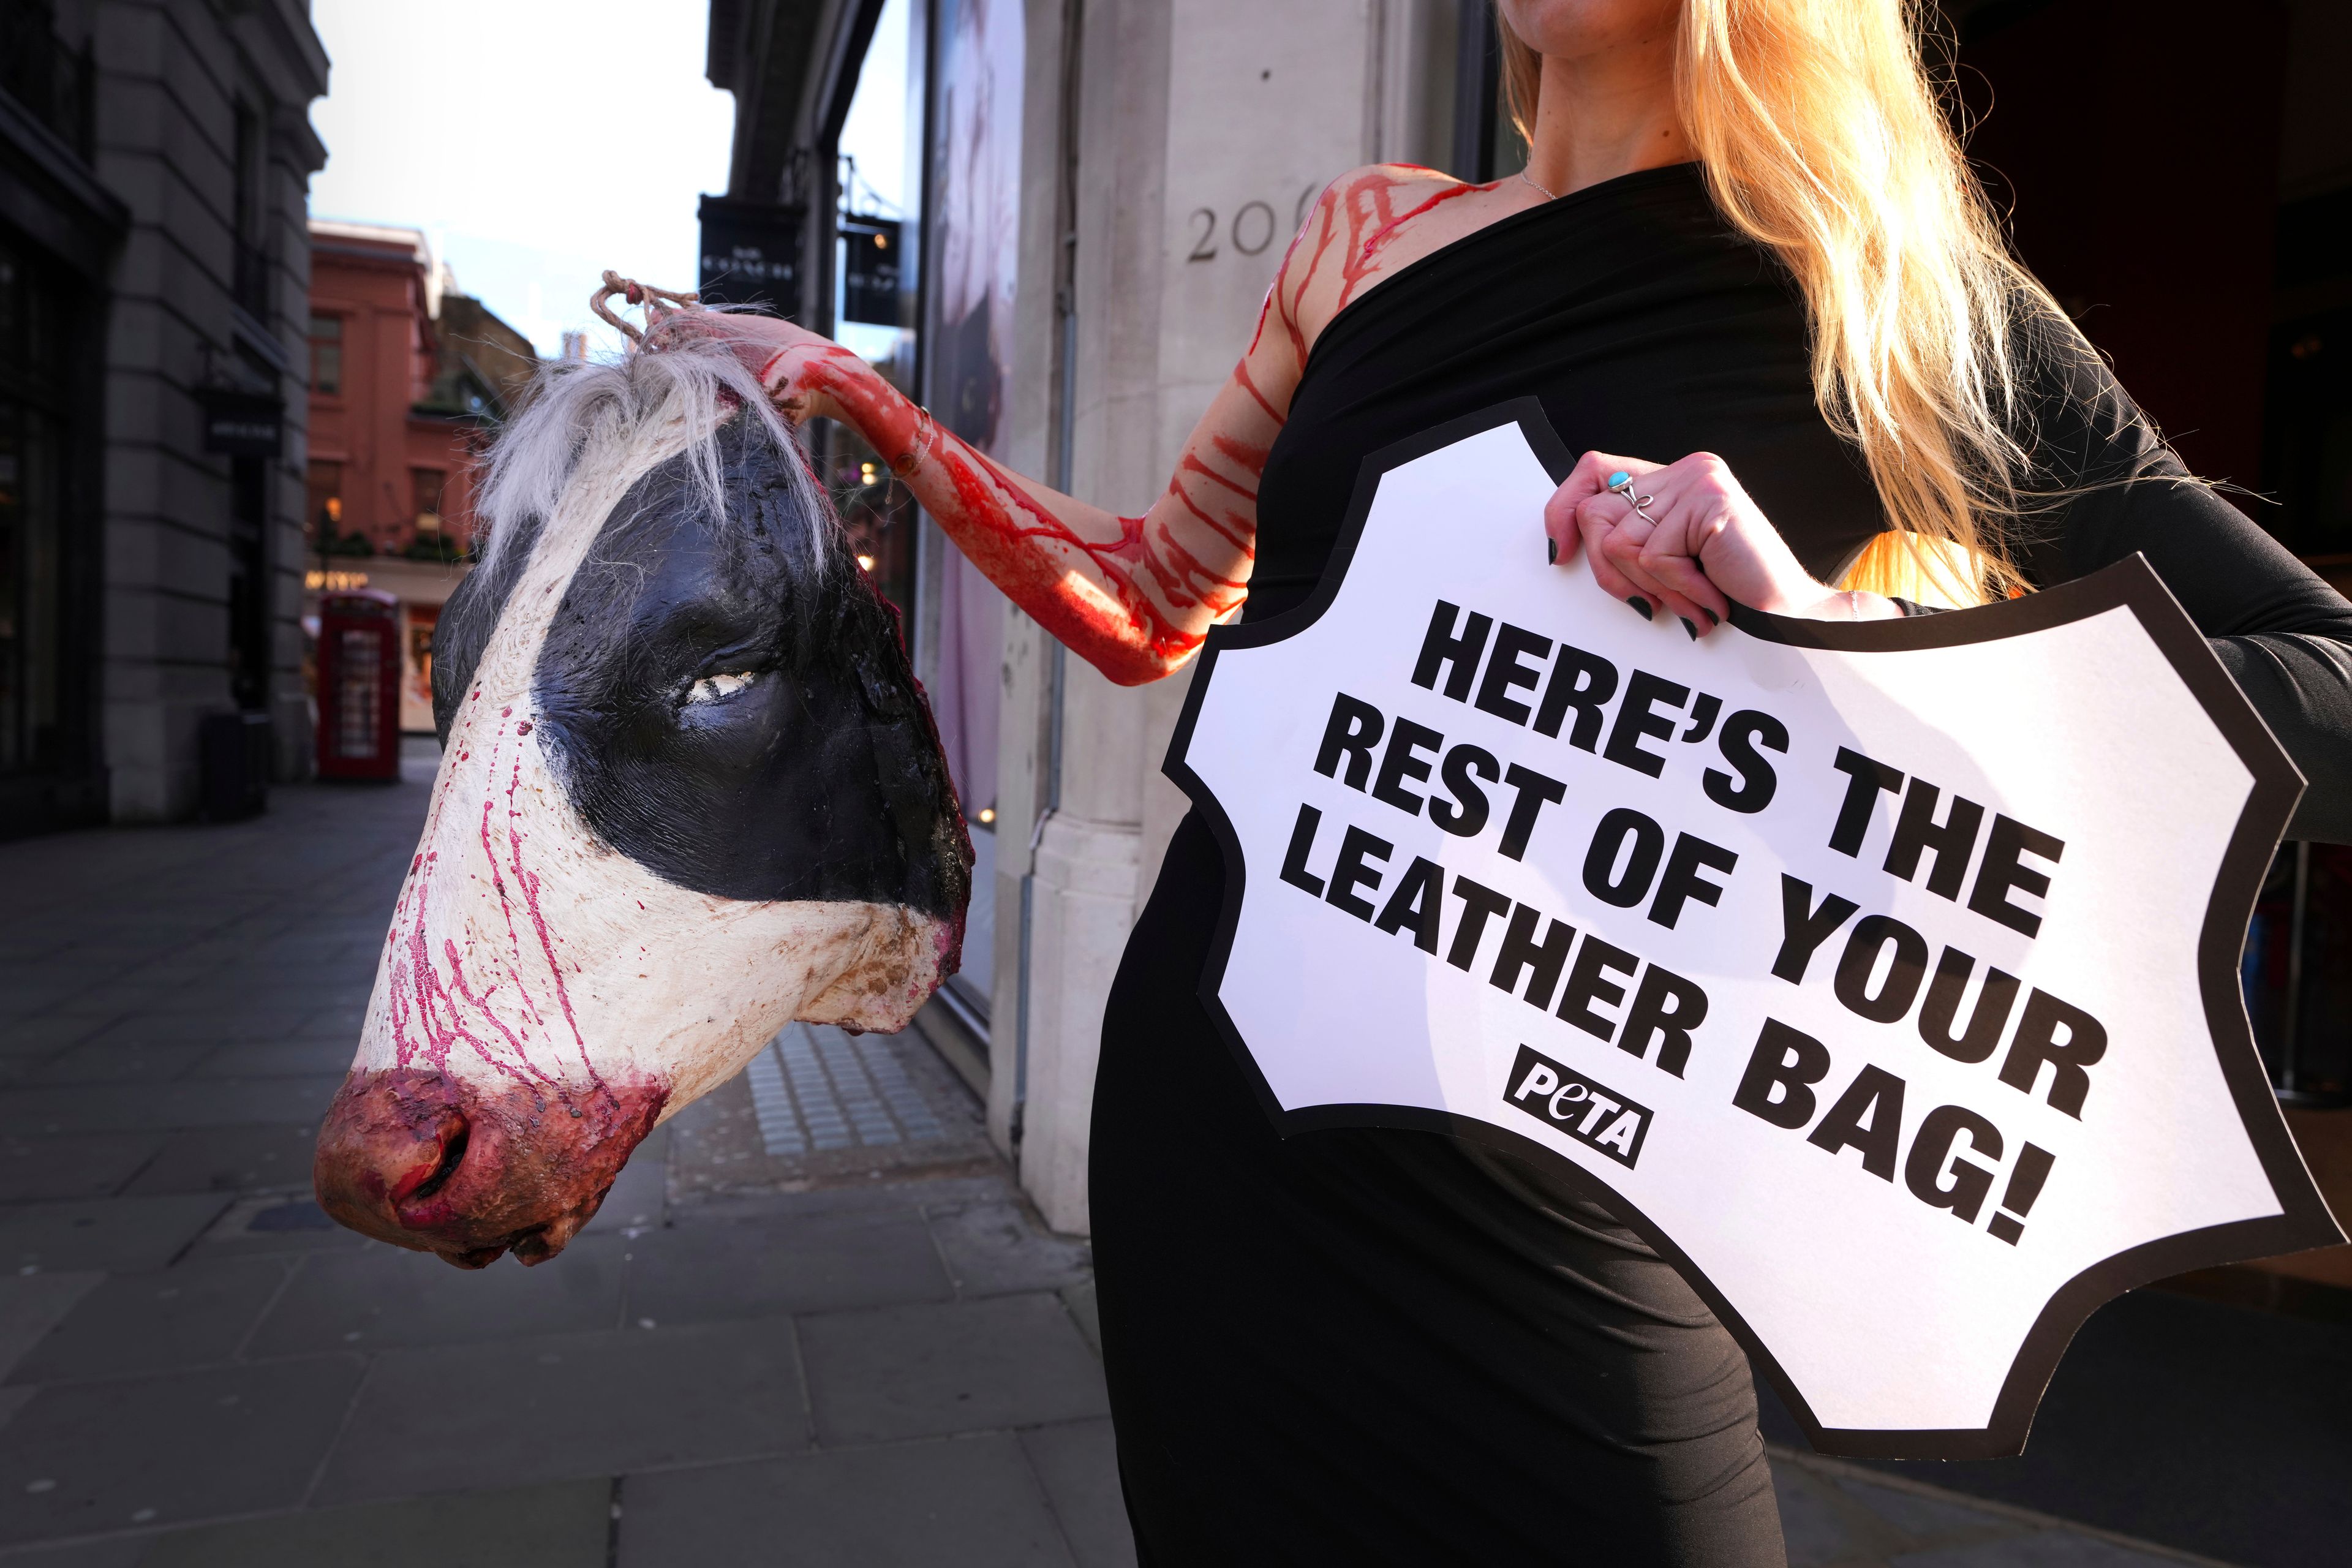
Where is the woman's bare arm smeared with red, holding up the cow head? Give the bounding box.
[652,167,1479,687]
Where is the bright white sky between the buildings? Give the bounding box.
[311,0,734,355]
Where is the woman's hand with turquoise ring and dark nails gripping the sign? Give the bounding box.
[1543,451,1903,637]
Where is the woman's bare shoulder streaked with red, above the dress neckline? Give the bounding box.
[1272,162,1526,350]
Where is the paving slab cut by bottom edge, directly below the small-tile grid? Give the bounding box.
[616,1434,1072,1568]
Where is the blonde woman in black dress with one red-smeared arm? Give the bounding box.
[680,0,2352,1566]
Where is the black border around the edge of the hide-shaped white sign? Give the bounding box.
[1162,398,2345,1460]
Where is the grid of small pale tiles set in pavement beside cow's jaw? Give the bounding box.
[745,1023,948,1154]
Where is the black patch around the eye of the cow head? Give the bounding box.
[532,421,964,914]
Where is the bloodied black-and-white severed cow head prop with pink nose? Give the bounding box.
[315,329,971,1267]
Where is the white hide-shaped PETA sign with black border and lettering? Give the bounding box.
[1169,399,2343,1458]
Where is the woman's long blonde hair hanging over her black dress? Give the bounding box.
[1501,0,2065,604]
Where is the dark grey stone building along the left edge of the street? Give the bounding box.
[0,0,327,837]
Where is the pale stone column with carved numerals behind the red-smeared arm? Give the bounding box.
[992,0,1449,1232]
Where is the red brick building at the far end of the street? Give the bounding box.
[306,221,538,731]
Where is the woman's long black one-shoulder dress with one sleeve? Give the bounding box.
[1091,165,2352,1568]
